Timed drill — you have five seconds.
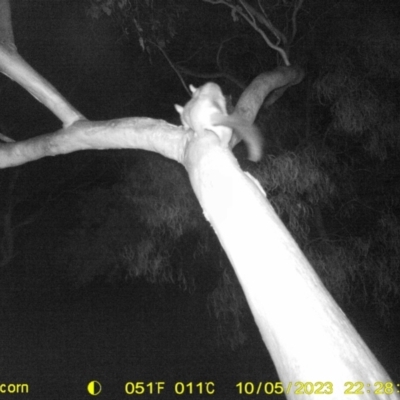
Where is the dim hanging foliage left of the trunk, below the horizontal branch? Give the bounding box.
[53,155,250,347]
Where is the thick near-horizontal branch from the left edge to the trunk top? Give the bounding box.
[0,118,192,168]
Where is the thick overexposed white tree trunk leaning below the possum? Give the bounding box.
[187,143,399,400]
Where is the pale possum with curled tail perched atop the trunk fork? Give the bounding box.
[175,82,263,161]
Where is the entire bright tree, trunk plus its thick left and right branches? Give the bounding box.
[0,0,399,400]
